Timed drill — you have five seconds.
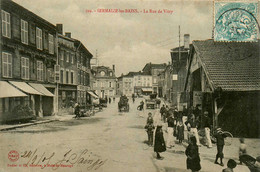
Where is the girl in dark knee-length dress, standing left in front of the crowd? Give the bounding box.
[154,125,166,160]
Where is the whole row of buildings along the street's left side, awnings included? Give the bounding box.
[0,0,116,122]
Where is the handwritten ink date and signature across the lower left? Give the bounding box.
[11,149,107,170]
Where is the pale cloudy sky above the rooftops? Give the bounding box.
[13,0,213,76]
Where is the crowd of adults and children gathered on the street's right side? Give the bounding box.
[145,105,258,172]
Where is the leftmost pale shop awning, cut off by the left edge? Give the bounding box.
[0,81,27,98]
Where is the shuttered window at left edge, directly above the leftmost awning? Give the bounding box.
[2,52,12,78]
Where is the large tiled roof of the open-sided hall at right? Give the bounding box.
[193,40,260,91]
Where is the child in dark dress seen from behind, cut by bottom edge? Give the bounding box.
[185,136,201,172]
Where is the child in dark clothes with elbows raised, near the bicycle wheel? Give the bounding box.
[214,128,227,166]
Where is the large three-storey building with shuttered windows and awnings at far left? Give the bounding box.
[0,0,57,120]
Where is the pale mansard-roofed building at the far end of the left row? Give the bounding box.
[92,65,116,98]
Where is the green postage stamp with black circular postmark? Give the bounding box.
[214,2,259,42]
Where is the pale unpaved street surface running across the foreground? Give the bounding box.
[0,99,259,172]
